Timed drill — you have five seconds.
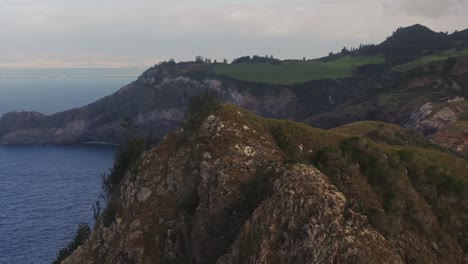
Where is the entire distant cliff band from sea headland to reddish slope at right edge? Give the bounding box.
[0,57,468,157]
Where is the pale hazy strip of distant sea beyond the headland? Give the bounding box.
[0,68,142,115]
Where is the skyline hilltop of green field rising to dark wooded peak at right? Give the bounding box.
[212,24,468,85]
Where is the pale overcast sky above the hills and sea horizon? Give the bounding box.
[0,0,468,69]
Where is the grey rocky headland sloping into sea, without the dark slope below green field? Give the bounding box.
[0,69,241,143]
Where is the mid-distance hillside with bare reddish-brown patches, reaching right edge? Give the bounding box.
[304,57,468,153]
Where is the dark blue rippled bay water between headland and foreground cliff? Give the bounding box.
[0,145,116,264]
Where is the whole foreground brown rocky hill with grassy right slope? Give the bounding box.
[63,106,468,264]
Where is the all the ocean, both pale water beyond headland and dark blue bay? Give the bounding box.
[0,69,141,264]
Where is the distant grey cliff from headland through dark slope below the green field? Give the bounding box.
[0,63,375,144]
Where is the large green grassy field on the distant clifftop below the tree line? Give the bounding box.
[214,55,385,85]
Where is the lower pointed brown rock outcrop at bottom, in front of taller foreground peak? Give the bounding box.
[218,165,403,263]
